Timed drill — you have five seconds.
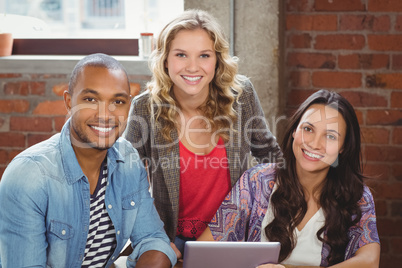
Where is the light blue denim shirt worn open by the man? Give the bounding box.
[0,121,176,268]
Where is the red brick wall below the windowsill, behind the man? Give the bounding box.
[0,73,149,177]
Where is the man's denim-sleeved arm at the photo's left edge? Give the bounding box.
[0,158,47,267]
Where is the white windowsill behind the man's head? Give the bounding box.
[0,55,151,75]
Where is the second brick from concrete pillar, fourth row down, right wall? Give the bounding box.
[338,54,389,70]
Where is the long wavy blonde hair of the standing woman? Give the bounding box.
[147,10,244,141]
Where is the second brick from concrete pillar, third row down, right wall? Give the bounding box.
[314,34,366,50]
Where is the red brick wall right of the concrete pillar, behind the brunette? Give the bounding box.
[284,0,402,267]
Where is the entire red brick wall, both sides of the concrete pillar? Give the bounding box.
[0,0,402,267]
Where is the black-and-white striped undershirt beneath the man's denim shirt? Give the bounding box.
[81,159,116,268]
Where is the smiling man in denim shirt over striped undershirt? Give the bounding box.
[0,54,176,268]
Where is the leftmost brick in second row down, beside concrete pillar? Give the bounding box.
[286,14,338,31]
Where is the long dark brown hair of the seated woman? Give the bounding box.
[265,90,364,265]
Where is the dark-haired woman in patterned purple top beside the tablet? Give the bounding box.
[200,90,380,267]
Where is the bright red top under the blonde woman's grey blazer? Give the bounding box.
[177,138,231,238]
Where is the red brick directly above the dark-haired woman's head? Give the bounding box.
[312,72,362,88]
